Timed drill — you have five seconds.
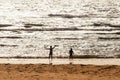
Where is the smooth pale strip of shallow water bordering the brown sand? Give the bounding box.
[0,58,120,65]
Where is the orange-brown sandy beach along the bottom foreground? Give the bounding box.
[0,64,120,80]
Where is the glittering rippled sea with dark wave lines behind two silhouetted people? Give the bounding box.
[0,0,120,57]
